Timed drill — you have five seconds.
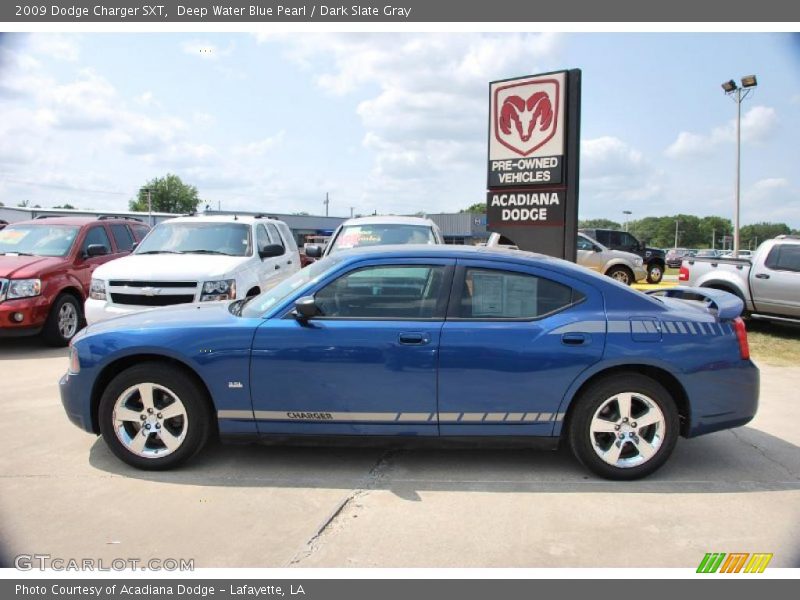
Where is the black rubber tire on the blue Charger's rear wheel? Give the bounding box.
[567,373,680,481]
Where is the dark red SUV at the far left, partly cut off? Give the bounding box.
[0,217,150,346]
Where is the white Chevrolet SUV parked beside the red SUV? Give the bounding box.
[84,215,300,324]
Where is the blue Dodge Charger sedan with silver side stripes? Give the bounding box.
[60,246,759,479]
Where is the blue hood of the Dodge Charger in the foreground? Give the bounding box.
[81,301,240,337]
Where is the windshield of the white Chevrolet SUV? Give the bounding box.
[136,222,251,256]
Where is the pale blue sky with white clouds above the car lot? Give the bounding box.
[0,33,800,227]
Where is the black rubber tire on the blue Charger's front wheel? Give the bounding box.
[98,362,213,471]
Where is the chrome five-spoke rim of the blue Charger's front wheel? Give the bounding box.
[112,383,189,458]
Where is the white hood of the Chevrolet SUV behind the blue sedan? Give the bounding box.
[93,254,249,281]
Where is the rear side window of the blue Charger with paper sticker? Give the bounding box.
[458,268,583,320]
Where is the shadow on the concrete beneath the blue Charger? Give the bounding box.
[89,427,800,494]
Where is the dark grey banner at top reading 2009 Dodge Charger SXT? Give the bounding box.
[0,0,800,23]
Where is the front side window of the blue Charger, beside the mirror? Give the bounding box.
[314,265,445,319]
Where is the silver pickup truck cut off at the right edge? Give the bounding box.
[678,235,800,323]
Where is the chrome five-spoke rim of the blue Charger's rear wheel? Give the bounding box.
[589,392,667,469]
